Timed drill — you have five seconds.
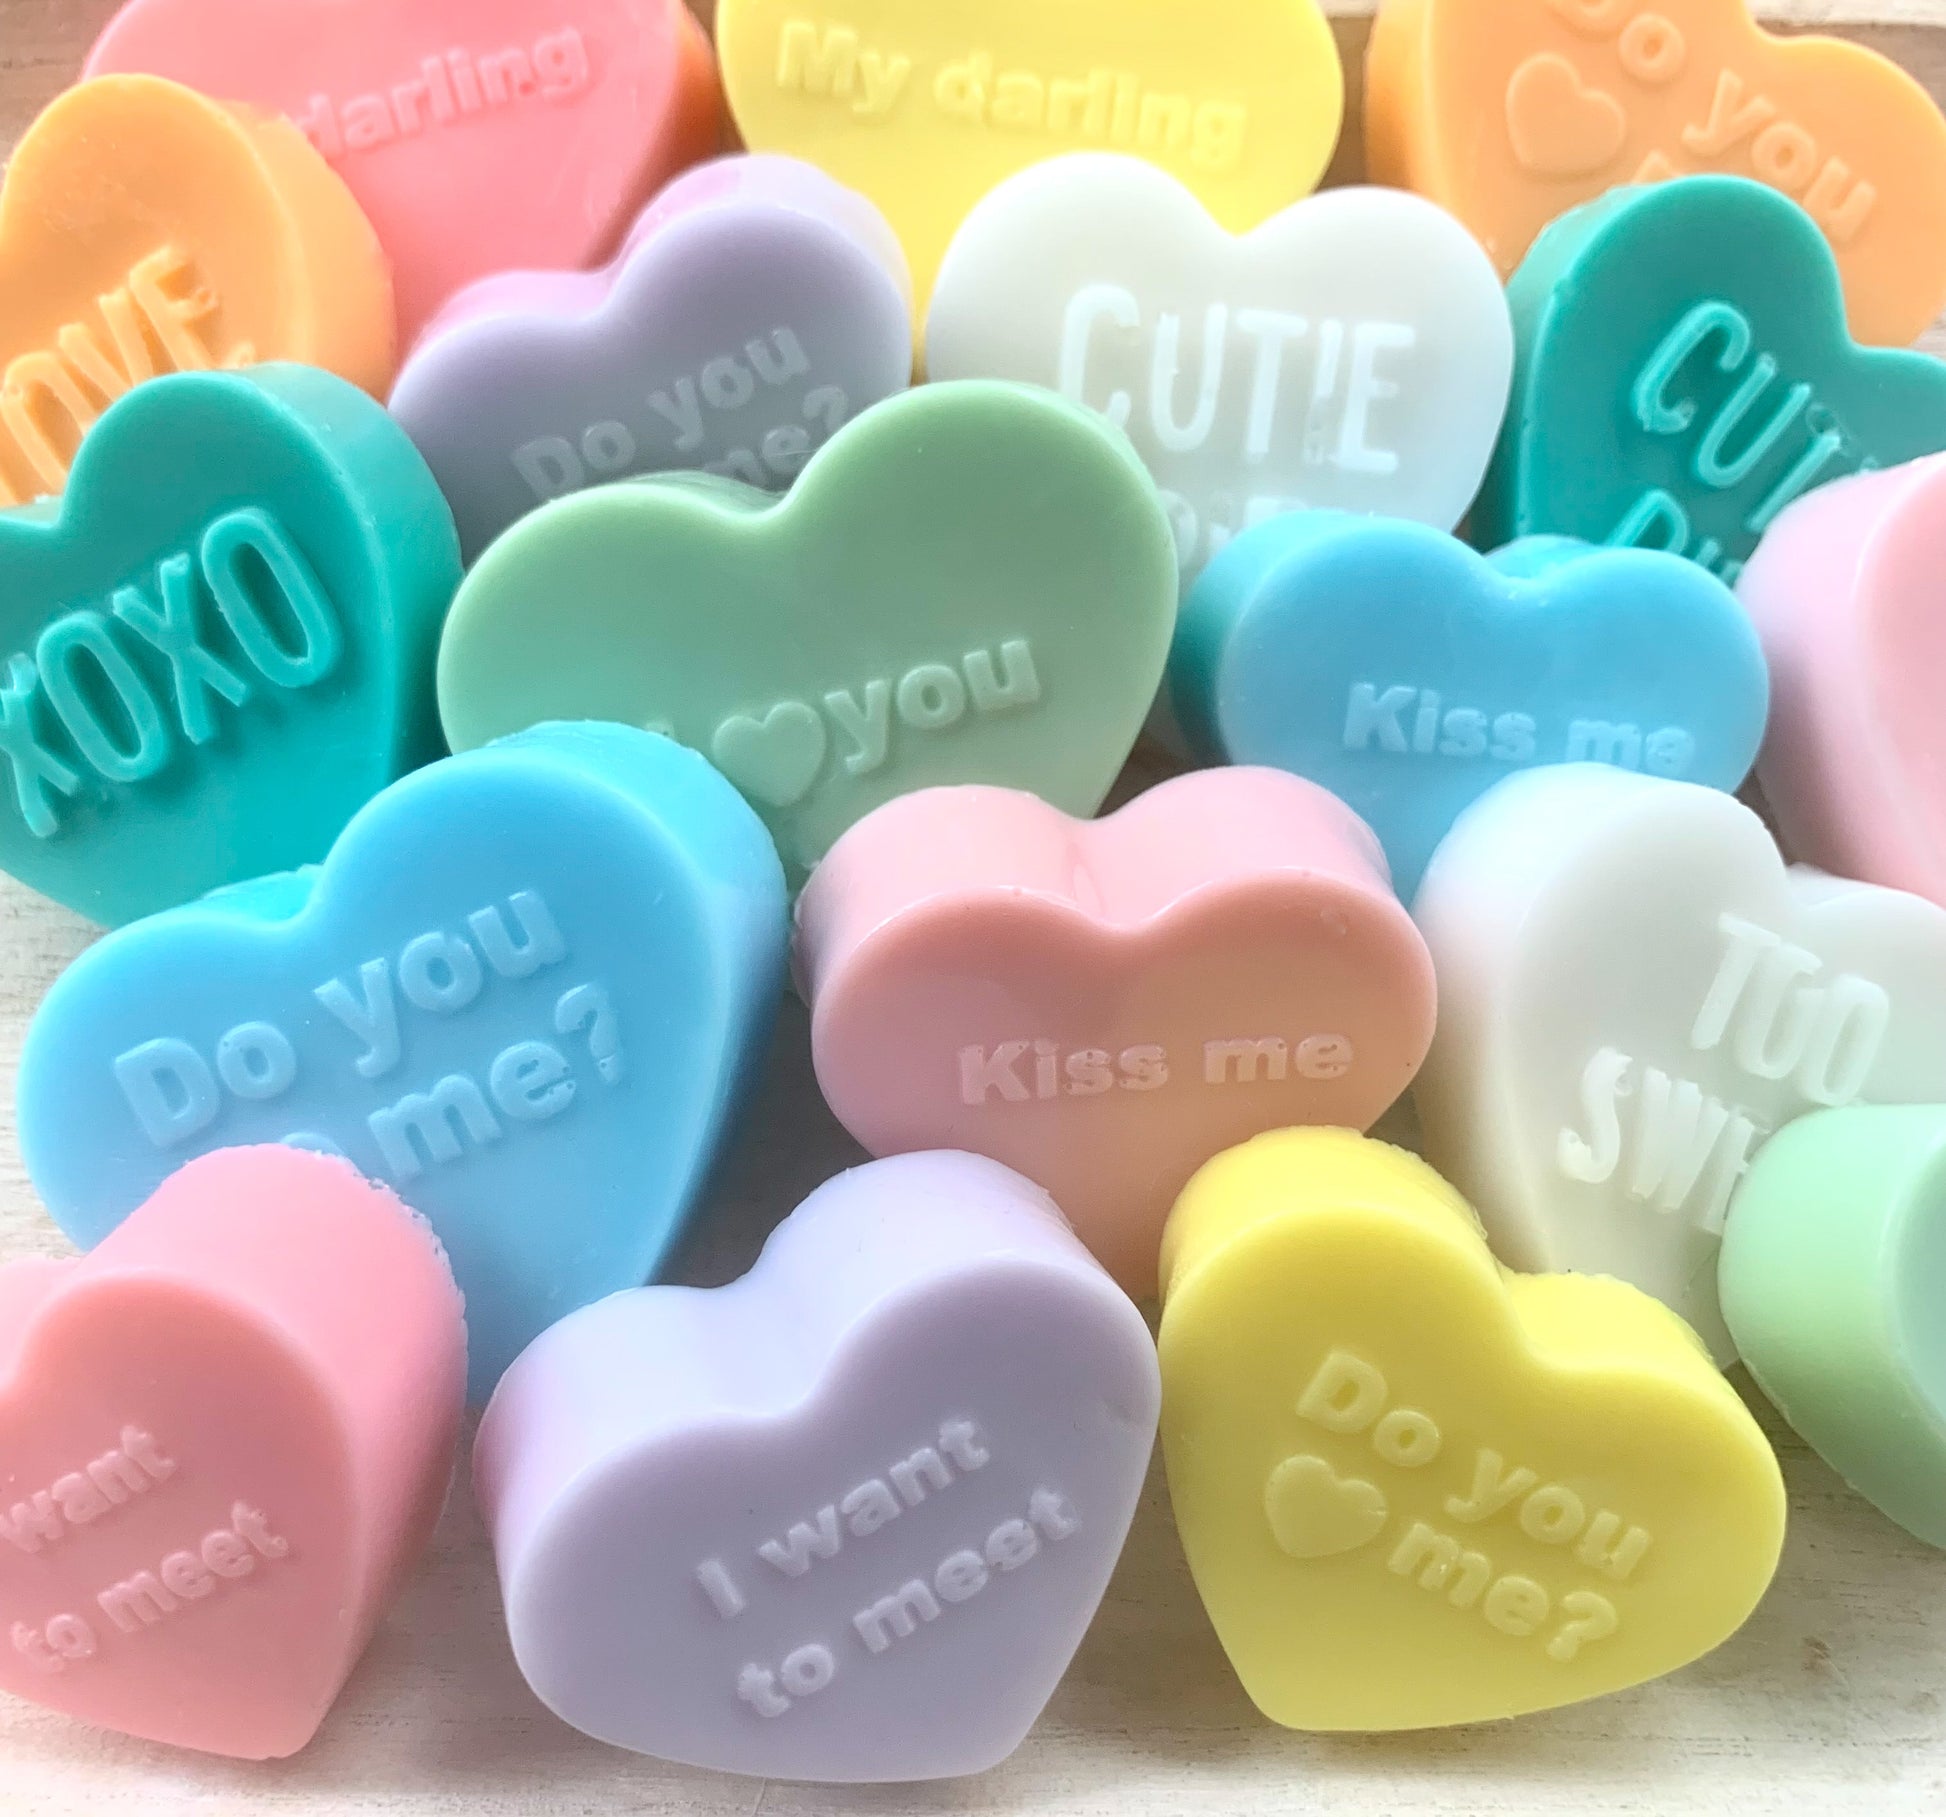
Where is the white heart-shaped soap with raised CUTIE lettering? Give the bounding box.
[926,154,1514,576]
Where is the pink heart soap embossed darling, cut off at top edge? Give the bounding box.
[88,0,722,342]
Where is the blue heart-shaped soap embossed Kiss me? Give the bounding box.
[1170,512,1769,901]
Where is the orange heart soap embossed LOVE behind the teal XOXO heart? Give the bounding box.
[0,76,395,506]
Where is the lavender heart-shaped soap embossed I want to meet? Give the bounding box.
[473,1154,1160,1782]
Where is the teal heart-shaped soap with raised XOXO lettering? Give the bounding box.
[0,366,459,924]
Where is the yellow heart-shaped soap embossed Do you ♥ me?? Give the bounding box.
[1160,1130,1784,1729]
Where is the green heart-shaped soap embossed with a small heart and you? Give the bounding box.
[440,381,1177,877]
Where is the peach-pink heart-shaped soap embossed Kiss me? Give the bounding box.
[796,770,1434,1296]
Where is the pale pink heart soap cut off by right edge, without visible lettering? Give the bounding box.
[1738,459,1946,903]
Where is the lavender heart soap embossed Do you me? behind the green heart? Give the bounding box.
[391,156,913,560]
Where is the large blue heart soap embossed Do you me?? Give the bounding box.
[19,726,786,1399]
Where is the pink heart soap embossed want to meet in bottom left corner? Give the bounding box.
[0,1148,467,1761]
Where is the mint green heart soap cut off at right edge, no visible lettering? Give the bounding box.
[1718,1105,1946,1547]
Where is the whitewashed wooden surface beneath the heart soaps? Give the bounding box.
[0,0,1946,1817]
